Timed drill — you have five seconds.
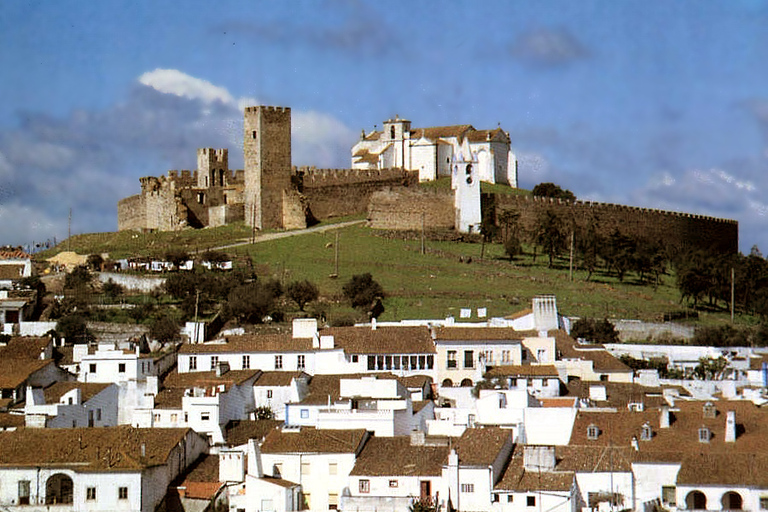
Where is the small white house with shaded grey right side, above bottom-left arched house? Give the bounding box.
[24,381,119,428]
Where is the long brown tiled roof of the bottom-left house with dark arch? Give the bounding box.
[0,425,195,471]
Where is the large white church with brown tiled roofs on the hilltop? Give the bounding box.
[352,116,517,188]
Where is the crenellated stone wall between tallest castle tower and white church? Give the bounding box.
[302,168,418,219]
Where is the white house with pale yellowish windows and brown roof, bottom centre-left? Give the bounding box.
[260,427,370,511]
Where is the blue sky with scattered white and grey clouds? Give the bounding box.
[0,0,768,251]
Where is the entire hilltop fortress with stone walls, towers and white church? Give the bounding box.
[117,106,738,253]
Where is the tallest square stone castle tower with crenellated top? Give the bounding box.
[243,106,296,229]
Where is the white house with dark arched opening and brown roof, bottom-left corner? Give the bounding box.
[0,426,207,512]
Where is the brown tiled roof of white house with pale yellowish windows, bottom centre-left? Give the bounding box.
[261,427,368,453]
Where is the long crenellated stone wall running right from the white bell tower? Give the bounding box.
[493,195,739,253]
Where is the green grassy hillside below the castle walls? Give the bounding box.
[40,219,727,323]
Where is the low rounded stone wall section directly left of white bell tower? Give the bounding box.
[368,187,455,230]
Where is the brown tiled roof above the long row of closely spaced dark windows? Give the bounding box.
[320,327,436,354]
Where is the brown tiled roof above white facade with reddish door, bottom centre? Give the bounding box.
[350,436,450,477]
